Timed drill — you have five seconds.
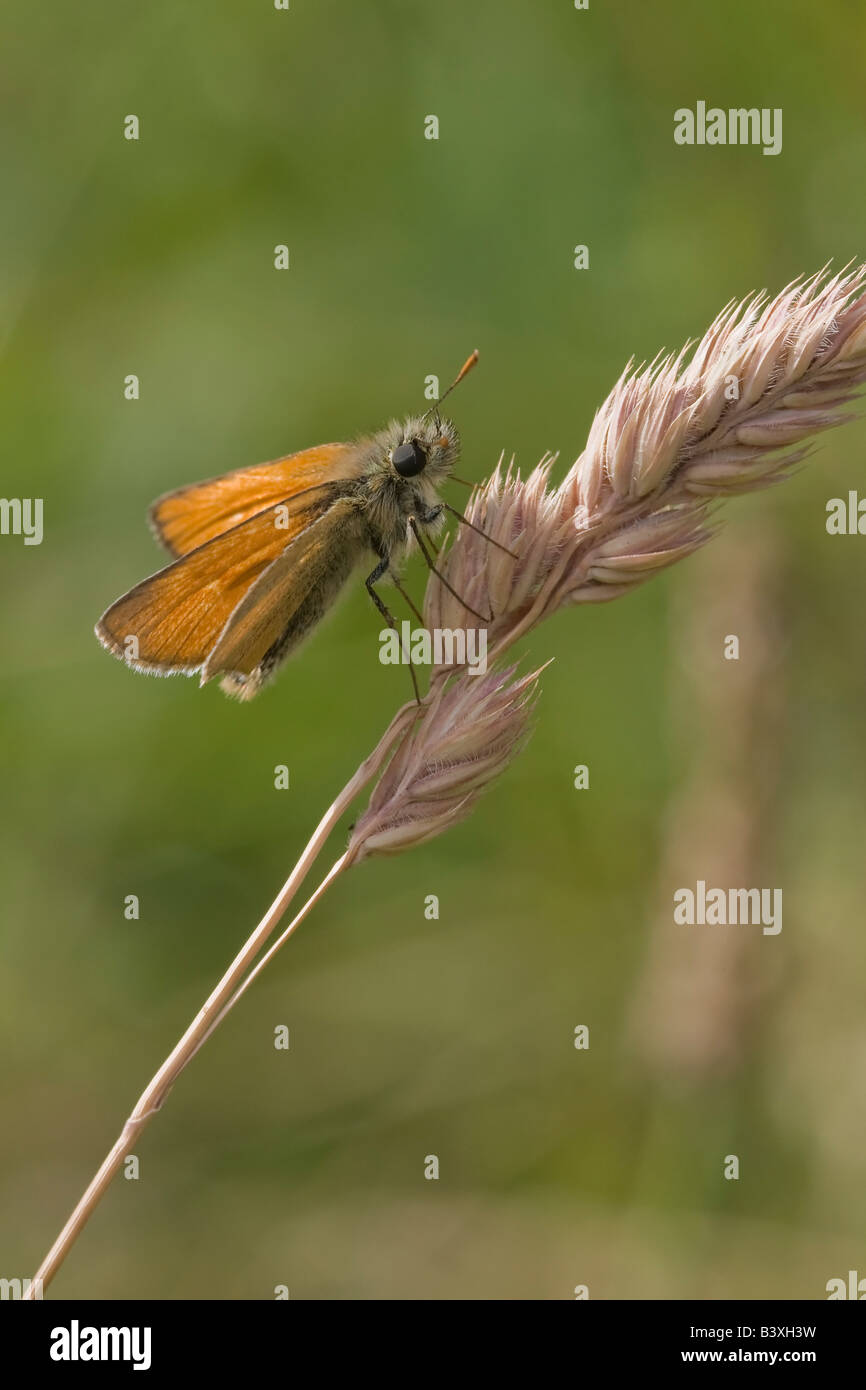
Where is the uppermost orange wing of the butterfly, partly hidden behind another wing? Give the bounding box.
[150,443,357,556]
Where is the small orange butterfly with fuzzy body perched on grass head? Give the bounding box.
[96,352,485,701]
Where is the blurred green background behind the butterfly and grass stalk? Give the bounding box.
[0,0,866,1298]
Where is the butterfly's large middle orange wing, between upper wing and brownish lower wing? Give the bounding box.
[96,481,361,676]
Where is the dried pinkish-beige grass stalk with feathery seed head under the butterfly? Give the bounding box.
[28,267,866,1297]
